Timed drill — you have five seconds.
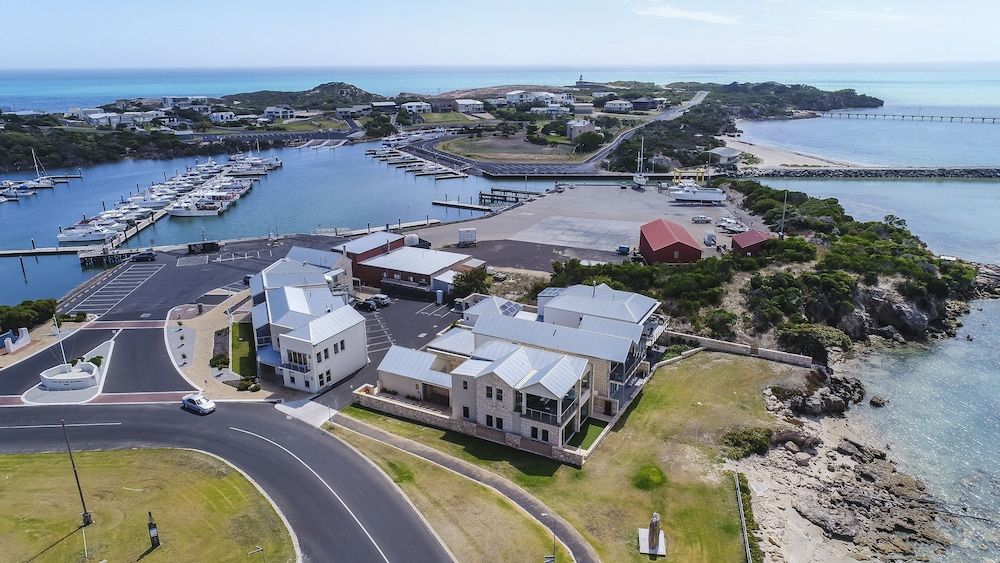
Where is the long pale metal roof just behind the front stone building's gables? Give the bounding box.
[472,315,632,363]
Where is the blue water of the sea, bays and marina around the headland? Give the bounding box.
[0,64,1000,561]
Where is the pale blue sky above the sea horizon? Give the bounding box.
[0,0,1000,69]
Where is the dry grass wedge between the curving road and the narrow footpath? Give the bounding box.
[337,431,571,562]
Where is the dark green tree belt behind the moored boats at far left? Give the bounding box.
[0,124,277,171]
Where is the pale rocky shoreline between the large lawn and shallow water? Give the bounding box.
[735,370,950,562]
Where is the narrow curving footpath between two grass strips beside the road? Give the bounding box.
[331,413,600,563]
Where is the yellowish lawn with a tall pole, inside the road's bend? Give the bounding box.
[0,450,295,562]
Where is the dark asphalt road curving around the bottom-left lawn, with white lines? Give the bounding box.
[0,403,450,562]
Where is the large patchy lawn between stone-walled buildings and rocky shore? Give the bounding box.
[342,352,798,562]
